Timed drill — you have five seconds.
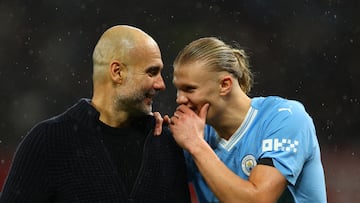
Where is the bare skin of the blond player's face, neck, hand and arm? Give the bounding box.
[164,61,287,203]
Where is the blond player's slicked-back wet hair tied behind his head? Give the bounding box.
[174,37,253,94]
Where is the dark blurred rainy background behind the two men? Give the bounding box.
[0,0,360,202]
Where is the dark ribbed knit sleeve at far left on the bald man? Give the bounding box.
[0,121,51,203]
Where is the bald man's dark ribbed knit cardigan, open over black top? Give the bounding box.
[0,99,190,203]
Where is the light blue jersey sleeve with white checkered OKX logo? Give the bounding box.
[260,101,316,185]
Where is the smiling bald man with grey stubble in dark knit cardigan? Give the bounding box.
[0,25,190,202]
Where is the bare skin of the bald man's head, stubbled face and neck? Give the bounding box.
[92,25,165,134]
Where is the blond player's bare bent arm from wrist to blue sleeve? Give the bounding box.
[189,141,287,203]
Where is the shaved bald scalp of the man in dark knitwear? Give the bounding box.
[93,25,157,82]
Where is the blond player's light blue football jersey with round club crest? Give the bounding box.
[185,96,327,203]
